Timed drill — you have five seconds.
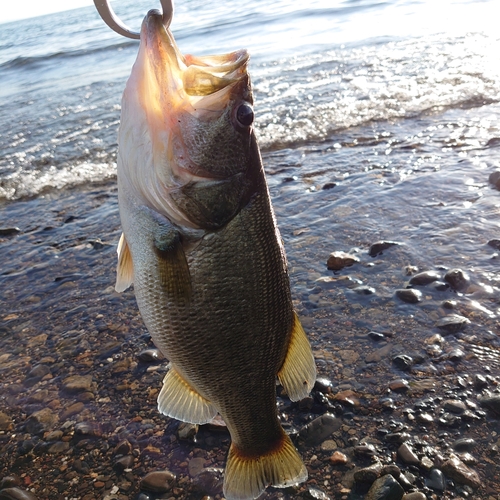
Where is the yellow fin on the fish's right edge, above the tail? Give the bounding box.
[278,312,316,401]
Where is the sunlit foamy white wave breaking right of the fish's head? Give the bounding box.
[254,35,500,150]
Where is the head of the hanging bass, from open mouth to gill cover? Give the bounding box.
[118,11,261,228]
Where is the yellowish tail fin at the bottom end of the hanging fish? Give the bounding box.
[224,432,307,500]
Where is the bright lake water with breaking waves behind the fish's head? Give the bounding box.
[0,0,500,200]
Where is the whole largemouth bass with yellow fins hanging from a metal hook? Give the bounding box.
[115,10,316,500]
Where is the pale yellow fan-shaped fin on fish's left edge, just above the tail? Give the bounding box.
[158,367,217,424]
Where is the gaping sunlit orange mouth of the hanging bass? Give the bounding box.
[141,10,251,118]
